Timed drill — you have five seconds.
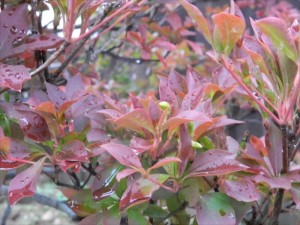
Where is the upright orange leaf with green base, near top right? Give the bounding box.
[212,12,246,55]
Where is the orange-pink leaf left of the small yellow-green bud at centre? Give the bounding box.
[114,109,154,133]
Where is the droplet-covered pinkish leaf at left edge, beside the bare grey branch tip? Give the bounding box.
[0,62,31,91]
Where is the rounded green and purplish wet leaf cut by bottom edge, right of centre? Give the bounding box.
[196,192,236,225]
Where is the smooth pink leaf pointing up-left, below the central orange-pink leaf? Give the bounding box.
[101,143,142,168]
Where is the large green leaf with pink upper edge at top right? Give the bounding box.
[253,17,298,62]
